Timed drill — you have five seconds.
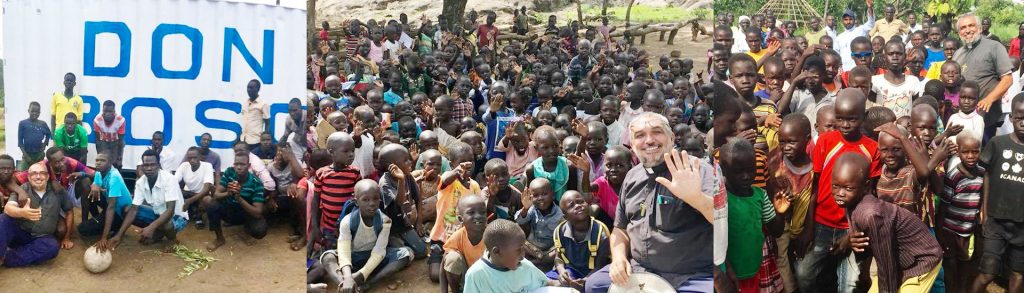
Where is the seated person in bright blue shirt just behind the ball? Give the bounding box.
[78,150,132,244]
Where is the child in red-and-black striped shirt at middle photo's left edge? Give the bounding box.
[308,132,360,255]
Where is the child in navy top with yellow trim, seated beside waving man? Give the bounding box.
[547,191,611,292]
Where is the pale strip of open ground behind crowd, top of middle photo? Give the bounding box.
[534,5,712,25]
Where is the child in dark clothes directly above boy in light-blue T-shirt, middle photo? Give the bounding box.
[482,159,522,221]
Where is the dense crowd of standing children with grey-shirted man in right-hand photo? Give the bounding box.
[716,5,1024,292]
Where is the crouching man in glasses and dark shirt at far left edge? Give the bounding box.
[0,163,74,267]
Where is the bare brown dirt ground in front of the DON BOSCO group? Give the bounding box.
[0,211,305,292]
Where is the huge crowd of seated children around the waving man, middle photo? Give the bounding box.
[296,8,712,292]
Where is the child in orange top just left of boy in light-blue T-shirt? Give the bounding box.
[441,195,487,292]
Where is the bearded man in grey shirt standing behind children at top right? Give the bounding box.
[953,13,1013,142]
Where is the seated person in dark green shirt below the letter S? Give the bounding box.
[203,152,266,251]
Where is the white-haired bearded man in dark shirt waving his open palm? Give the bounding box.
[586,113,719,292]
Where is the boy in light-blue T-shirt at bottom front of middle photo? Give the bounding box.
[464,219,558,293]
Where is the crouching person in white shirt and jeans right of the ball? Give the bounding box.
[108,150,188,250]
